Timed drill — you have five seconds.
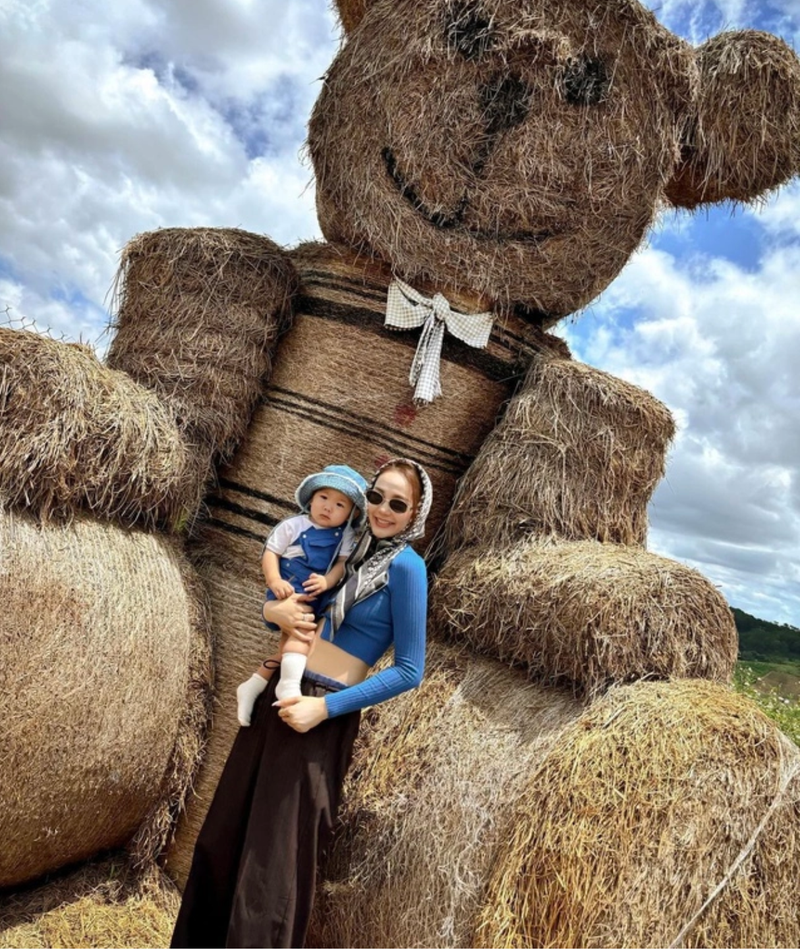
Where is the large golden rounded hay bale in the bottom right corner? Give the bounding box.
[473,681,800,947]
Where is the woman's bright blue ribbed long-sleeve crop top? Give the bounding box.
[322,548,428,717]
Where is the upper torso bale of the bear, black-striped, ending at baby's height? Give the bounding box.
[194,237,569,554]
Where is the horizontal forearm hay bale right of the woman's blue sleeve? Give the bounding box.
[431,540,737,696]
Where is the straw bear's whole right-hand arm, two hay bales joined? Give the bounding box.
[432,357,736,697]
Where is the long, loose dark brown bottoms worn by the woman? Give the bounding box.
[171,674,359,947]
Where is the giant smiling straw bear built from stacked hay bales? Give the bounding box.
[0,0,800,947]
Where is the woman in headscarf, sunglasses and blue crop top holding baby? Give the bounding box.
[172,459,431,947]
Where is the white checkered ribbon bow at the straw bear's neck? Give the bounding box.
[385,278,494,405]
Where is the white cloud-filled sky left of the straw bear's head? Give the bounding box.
[0,0,336,336]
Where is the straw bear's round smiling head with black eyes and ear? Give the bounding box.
[309,0,800,326]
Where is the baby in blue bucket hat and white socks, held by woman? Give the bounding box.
[236,465,367,726]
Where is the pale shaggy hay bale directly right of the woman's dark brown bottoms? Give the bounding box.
[307,643,581,947]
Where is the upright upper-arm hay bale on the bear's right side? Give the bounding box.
[445,357,675,550]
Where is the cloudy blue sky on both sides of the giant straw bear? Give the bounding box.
[0,0,800,626]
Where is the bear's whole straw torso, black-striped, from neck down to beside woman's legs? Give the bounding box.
[162,244,568,881]
